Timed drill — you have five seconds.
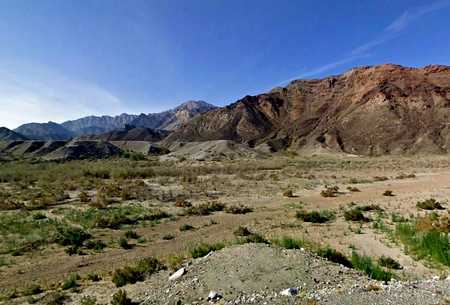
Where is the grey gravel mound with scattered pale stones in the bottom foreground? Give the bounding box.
[22,244,450,305]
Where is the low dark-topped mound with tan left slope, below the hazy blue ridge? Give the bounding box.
[43,140,124,161]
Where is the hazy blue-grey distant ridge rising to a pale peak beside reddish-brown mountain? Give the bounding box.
[61,101,217,135]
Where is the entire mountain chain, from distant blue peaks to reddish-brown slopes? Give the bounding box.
[0,64,450,155]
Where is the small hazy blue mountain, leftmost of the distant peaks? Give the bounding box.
[14,122,75,140]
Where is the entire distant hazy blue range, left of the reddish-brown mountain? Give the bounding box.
[10,101,217,140]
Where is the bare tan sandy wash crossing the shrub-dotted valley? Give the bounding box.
[0,157,450,300]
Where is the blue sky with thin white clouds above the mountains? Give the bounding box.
[0,0,450,129]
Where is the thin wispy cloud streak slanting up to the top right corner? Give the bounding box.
[282,0,450,84]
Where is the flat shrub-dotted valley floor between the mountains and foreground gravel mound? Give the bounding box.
[0,154,450,304]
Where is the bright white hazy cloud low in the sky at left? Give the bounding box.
[0,63,128,129]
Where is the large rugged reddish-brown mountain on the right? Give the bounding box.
[166,64,450,154]
